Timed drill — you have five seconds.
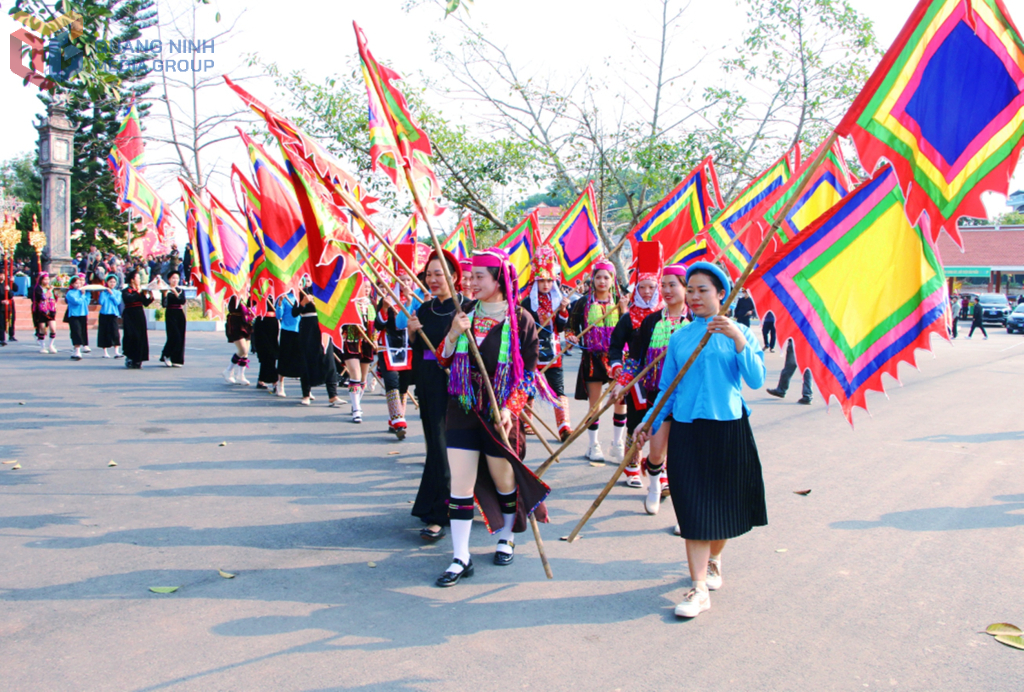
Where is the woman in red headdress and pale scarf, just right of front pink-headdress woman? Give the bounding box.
[520,246,572,442]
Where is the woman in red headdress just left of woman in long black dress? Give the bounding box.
[374,243,420,440]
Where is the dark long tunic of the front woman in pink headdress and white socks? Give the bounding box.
[444,307,551,533]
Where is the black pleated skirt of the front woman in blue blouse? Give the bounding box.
[667,415,768,540]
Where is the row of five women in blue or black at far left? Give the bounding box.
[32,270,185,370]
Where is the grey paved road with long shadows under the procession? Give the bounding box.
[0,330,1024,692]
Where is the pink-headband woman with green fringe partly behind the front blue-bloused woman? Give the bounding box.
[614,264,686,515]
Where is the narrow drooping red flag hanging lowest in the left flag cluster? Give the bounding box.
[282,145,362,347]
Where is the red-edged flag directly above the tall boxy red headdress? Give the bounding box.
[629,157,725,253]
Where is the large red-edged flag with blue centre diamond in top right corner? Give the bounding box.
[836,0,1024,246]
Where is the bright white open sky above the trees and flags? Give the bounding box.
[0,0,1024,245]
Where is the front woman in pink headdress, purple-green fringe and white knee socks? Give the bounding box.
[436,248,554,587]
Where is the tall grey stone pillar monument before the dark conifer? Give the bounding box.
[36,94,78,274]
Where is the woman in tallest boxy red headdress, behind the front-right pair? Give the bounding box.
[608,241,669,492]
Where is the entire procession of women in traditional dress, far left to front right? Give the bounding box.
[22,237,767,617]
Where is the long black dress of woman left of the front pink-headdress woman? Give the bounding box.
[412,298,464,526]
